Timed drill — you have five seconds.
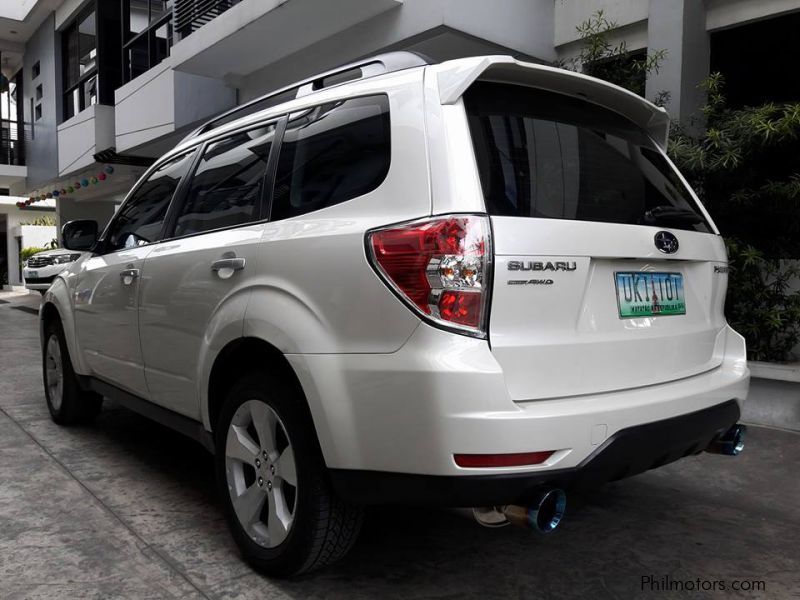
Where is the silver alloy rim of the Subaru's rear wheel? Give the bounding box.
[225,400,297,548]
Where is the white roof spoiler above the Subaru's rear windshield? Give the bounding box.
[431,56,670,150]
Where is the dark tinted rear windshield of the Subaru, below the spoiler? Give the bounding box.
[464,82,711,232]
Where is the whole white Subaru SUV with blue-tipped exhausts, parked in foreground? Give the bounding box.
[41,53,749,576]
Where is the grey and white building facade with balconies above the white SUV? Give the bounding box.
[0,0,800,232]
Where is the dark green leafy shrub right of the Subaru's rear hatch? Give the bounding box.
[669,73,800,361]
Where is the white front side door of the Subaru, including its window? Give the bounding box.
[74,155,196,398]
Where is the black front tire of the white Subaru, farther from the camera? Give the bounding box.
[42,320,103,425]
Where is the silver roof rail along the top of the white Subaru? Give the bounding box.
[182,51,432,142]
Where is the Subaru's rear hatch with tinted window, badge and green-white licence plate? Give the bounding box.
[464,82,727,400]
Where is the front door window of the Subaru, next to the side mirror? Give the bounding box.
[106,153,193,252]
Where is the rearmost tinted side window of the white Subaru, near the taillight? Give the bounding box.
[271,95,391,221]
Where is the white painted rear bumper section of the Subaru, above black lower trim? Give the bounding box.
[287,324,750,488]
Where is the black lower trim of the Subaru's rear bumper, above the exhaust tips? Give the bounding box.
[330,400,740,507]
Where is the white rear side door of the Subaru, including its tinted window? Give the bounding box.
[139,123,276,419]
